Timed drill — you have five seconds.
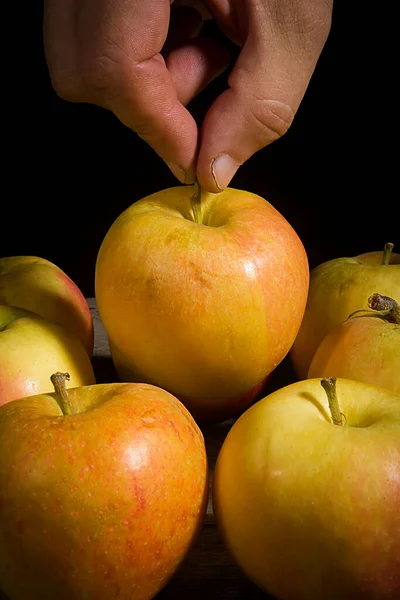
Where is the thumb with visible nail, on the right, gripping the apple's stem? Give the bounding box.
[197,0,331,192]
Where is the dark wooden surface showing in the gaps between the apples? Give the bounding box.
[0,298,294,600]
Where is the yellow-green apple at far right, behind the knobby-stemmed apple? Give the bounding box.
[290,243,400,379]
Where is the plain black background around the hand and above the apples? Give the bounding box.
[0,0,400,296]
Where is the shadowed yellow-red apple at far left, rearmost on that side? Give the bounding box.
[0,256,94,356]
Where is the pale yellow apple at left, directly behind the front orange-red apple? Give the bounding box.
[0,305,95,406]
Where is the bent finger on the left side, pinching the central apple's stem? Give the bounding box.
[49,0,198,183]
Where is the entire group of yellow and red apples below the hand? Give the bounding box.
[0,185,400,600]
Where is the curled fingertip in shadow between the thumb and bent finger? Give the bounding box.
[166,37,230,106]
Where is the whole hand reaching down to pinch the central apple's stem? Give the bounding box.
[44,0,333,192]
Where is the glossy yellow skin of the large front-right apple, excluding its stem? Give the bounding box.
[213,379,400,600]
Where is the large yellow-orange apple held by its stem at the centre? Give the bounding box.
[95,185,309,421]
